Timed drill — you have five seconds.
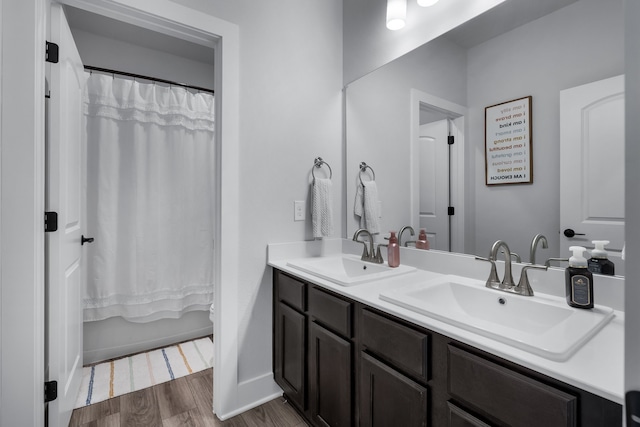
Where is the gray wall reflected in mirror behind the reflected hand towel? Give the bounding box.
[346,39,467,242]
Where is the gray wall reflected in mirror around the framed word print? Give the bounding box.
[467,0,624,258]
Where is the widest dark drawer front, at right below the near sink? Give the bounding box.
[448,345,578,427]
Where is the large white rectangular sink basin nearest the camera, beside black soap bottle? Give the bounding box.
[380,275,614,361]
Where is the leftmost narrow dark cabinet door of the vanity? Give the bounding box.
[274,303,306,411]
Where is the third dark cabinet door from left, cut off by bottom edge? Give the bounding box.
[360,353,428,427]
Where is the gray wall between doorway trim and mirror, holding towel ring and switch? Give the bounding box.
[164,0,343,384]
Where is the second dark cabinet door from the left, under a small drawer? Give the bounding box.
[309,322,353,427]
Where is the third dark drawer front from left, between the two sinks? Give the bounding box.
[362,309,429,382]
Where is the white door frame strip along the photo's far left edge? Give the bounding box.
[0,0,47,427]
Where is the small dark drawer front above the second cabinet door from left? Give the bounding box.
[308,287,353,338]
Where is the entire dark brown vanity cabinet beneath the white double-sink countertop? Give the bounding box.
[273,270,622,427]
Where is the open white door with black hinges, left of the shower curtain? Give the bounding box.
[45,4,86,427]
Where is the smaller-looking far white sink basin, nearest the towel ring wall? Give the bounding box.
[287,254,416,286]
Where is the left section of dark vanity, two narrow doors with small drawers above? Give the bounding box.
[273,271,354,427]
